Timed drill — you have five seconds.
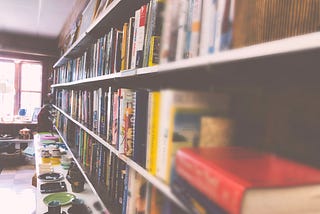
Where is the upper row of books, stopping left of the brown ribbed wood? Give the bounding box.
[54,0,234,84]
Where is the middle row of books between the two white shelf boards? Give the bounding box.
[53,87,233,184]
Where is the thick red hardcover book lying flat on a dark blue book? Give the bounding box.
[176,147,320,214]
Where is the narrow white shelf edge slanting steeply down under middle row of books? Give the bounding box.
[54,106,189,213]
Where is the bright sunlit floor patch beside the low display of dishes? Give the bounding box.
[0,164,36,214]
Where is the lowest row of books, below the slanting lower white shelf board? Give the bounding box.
[59,114,188,214]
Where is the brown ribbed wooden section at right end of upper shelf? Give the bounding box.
[233,0,320,48]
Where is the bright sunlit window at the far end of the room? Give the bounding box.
[0,60,42,120]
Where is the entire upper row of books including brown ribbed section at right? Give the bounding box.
[54,0,319,84]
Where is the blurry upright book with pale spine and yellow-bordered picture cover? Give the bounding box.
[156,89,230,184]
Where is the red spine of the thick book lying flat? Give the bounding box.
[176,150,245,214]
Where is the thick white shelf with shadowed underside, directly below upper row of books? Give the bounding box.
[52,32,320,88]
